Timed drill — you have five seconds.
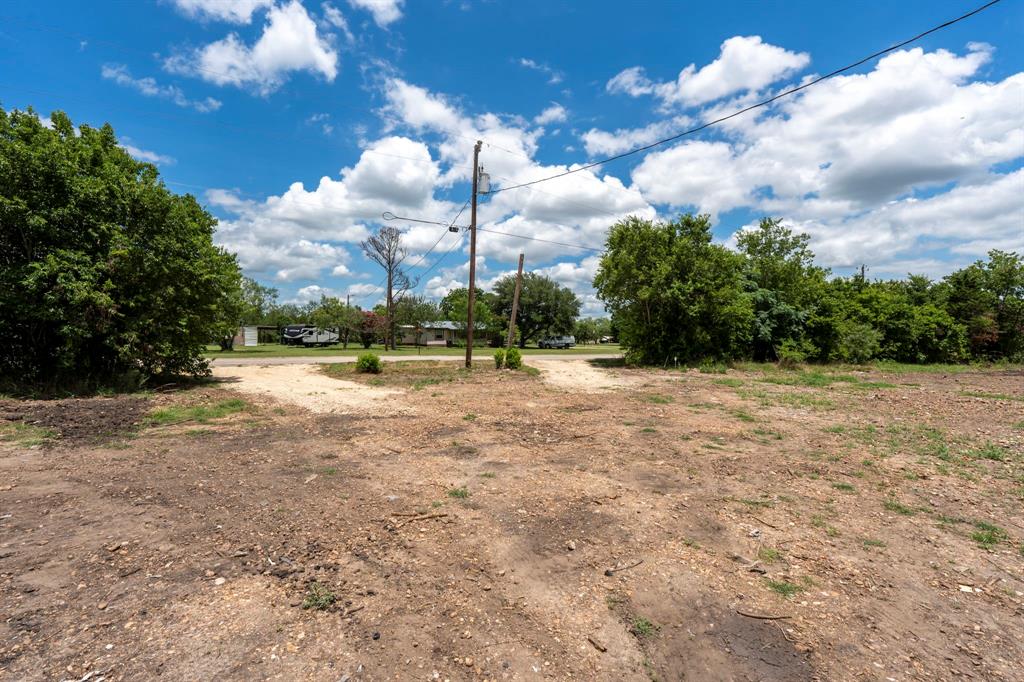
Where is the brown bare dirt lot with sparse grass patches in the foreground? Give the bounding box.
[0,360,1024,682]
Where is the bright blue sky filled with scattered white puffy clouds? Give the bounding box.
[0,0,1024,313]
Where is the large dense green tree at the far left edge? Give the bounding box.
[0,110,241,389]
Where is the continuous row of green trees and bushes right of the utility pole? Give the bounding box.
[594,214,1024,365]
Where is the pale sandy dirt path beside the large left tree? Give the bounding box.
[213,364,412,415]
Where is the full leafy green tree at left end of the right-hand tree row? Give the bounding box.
[594,214,754,365]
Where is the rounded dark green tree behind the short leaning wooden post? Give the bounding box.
[489,272,580,348]
